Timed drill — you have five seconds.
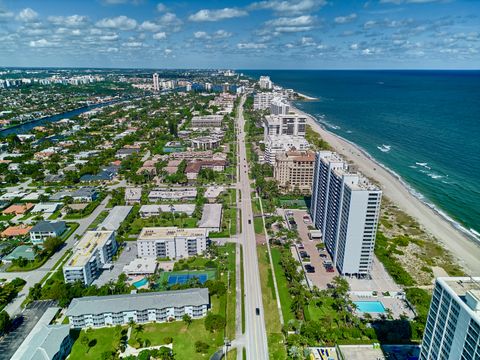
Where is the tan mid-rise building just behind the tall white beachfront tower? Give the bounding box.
[273,151,315,193]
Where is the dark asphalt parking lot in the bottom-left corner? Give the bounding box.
[0,300,56,360]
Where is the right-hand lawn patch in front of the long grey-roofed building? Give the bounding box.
[128,319,223,360]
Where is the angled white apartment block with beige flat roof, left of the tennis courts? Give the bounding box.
[63,231,118,285]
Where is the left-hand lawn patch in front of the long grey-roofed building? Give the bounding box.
[69,327,126,360]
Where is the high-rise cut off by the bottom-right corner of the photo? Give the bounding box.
[420,277,480,360]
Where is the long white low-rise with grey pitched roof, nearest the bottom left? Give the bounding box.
[66,288,210,329]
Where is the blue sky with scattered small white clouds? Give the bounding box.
[0,0,480,69]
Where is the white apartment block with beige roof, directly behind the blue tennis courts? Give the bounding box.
[137,227,208,259]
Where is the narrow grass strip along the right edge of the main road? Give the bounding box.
[257,245,287,360]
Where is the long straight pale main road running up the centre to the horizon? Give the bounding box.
[237,95,268,360]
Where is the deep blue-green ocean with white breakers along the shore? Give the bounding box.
[241,70,480,241]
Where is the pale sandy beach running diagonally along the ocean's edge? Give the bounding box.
[296,109,480,276]
